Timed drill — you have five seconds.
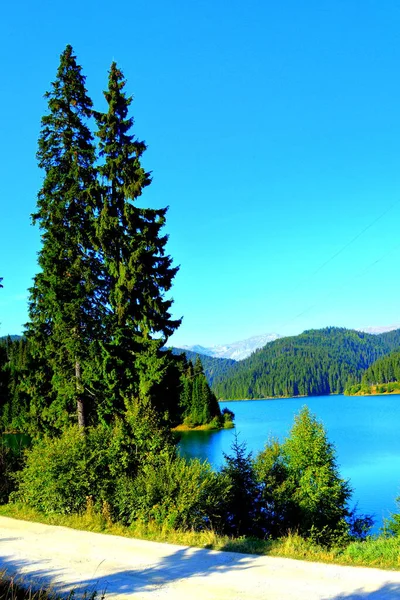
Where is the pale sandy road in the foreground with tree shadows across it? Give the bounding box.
[0,517,400,600]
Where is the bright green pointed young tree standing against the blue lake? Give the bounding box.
[256,407,351,545]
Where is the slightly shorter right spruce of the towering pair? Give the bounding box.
[96,62,180,408]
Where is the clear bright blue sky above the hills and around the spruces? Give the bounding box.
[0,0,400,346]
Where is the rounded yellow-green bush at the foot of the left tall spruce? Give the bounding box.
[12,423,137,514]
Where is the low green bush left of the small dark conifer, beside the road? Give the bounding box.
[116,452,229,531]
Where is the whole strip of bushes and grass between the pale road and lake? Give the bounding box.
[0,407,400,569]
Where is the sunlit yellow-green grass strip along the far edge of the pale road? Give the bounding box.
[0,504,400,568]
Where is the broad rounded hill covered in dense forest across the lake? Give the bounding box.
[213,327,400,399]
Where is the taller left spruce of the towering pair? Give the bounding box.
[27,45,104,428]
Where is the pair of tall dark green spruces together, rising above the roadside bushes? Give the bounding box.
[14,45,180,434]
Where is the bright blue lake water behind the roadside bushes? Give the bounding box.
[179,395,400,532]
